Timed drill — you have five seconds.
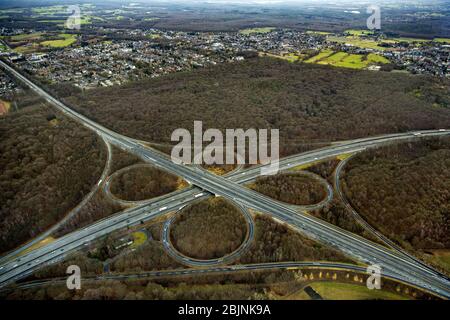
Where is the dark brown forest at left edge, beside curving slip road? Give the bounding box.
[0,105,106,252]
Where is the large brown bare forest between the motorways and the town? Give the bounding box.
[65,57,450,156]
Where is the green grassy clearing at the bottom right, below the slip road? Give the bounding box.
[310,281,407,300]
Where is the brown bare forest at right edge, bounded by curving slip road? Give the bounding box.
[341,138,450,250]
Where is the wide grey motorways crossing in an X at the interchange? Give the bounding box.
[0,62,450,298]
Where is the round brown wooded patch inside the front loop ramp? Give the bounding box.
[170,198,247,259]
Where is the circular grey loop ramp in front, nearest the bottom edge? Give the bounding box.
[161,199,255,267]
